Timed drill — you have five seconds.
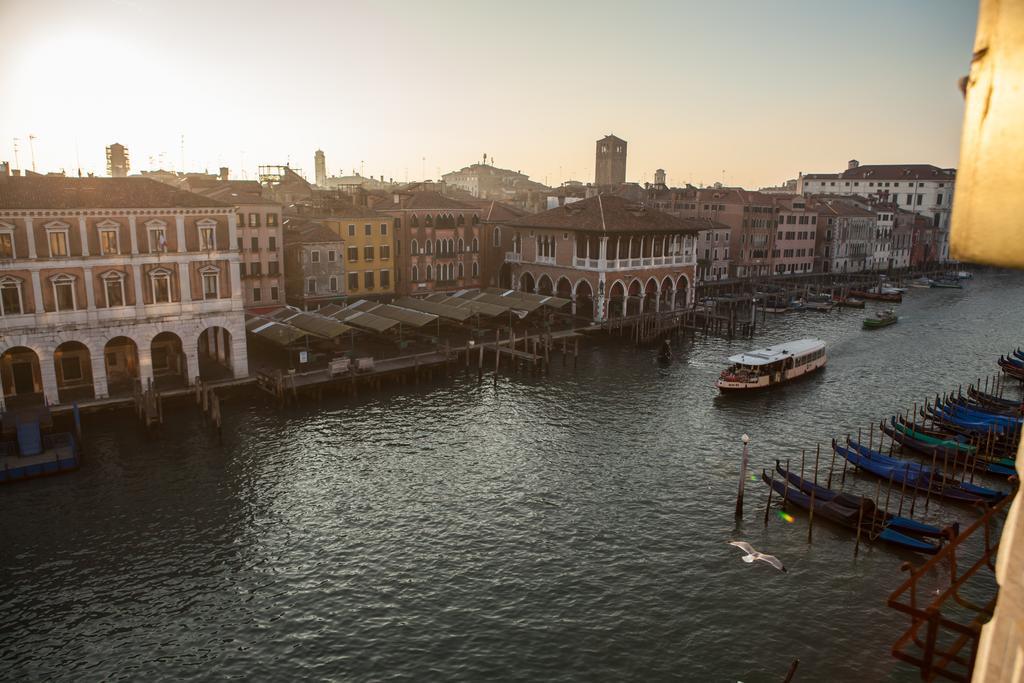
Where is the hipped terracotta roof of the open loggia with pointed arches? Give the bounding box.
[507,195,716,232]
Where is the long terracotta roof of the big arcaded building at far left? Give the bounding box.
[0,175,230,209]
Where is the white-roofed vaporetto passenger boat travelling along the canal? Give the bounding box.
[715,339,828,391]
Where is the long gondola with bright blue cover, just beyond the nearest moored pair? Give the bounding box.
[833,439,1006,504]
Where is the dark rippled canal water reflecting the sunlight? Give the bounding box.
[0,273,1024,681]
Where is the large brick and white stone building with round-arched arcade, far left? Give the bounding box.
[0,175,248,405]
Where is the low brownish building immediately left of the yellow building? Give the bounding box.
[285,216,345,310]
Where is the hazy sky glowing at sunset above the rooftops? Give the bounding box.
[0,0,977,187]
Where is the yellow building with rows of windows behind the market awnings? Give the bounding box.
[319,206,396,301]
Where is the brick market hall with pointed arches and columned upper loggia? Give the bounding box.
[495,195,716,321]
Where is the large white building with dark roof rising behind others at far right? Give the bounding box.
[797,159,956,260]
